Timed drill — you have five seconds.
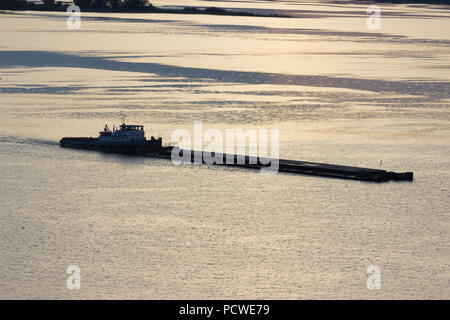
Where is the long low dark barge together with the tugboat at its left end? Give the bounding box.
[60,124,414,182]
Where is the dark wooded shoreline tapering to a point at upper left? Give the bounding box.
[0,1,292,18]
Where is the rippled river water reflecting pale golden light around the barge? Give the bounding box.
[0,1,450,299]
